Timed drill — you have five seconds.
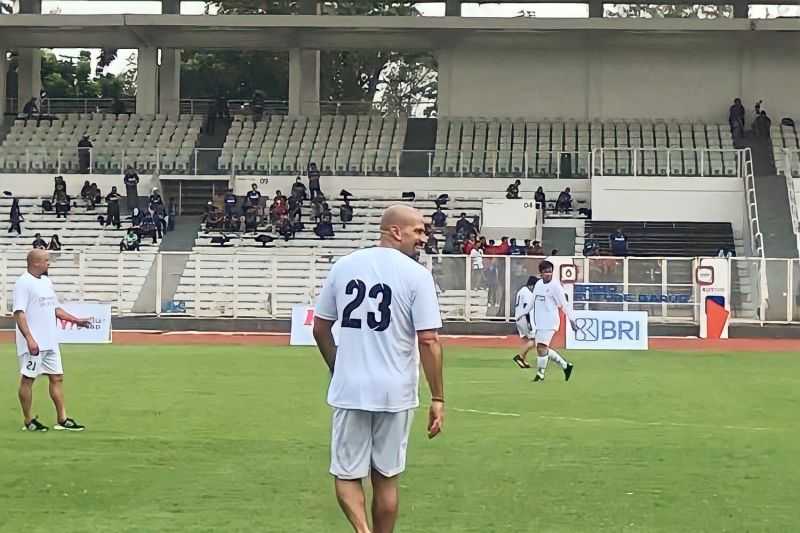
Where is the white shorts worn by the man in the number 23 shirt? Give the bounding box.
[330,408,414,479]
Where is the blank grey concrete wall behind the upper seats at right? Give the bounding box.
[438,31,800,123]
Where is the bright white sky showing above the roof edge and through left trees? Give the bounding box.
[23,0,800,74]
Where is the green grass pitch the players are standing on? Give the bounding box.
[0,345,800,533]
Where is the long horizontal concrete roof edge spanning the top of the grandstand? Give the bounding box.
[0,15,800,50]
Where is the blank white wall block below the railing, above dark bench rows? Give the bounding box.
[592,177,745,235]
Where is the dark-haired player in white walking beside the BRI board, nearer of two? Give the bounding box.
[531,261,577,381]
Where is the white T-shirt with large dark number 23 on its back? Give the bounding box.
[315,246,442,412]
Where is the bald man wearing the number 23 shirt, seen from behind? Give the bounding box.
[314,205,444,533]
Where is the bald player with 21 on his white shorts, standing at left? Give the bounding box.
[14,250,92,431]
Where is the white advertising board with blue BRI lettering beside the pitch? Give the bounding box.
[567,311,647,350]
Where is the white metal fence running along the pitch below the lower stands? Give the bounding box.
[0,251,800,324]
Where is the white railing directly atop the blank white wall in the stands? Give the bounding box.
[591,147,744,178]
